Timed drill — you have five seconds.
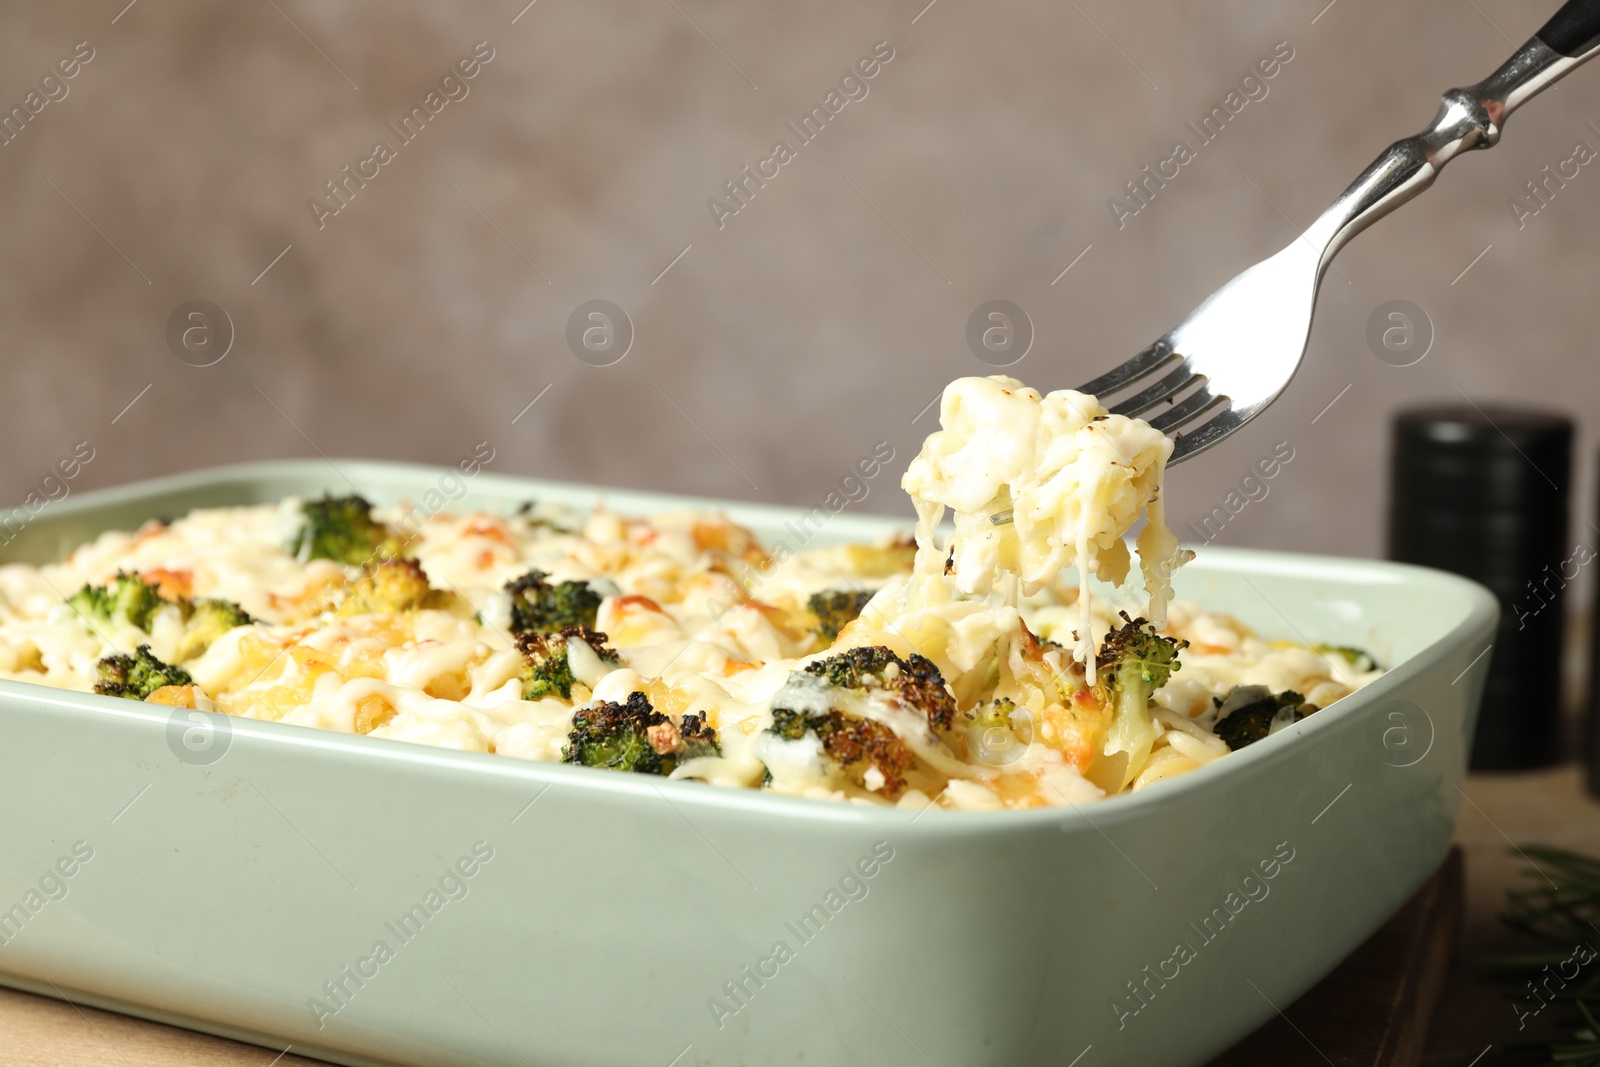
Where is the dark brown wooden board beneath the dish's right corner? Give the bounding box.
[1211,848,1464,1067]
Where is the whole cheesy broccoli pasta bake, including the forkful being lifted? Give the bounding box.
[0,378,1378,809]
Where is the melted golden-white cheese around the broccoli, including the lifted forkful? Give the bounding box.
[0,390,1376,809]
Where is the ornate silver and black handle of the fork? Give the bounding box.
[1304,0,1600,272]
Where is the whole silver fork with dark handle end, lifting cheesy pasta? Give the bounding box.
[994,0,1600,525]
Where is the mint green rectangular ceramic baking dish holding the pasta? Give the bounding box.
[0,461,1496,1067]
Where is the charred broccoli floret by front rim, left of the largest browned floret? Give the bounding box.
[562,693,722,776]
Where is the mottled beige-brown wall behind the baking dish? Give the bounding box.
[0,0,1600,566]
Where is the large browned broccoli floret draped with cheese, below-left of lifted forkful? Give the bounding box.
[768,646,955,797]
